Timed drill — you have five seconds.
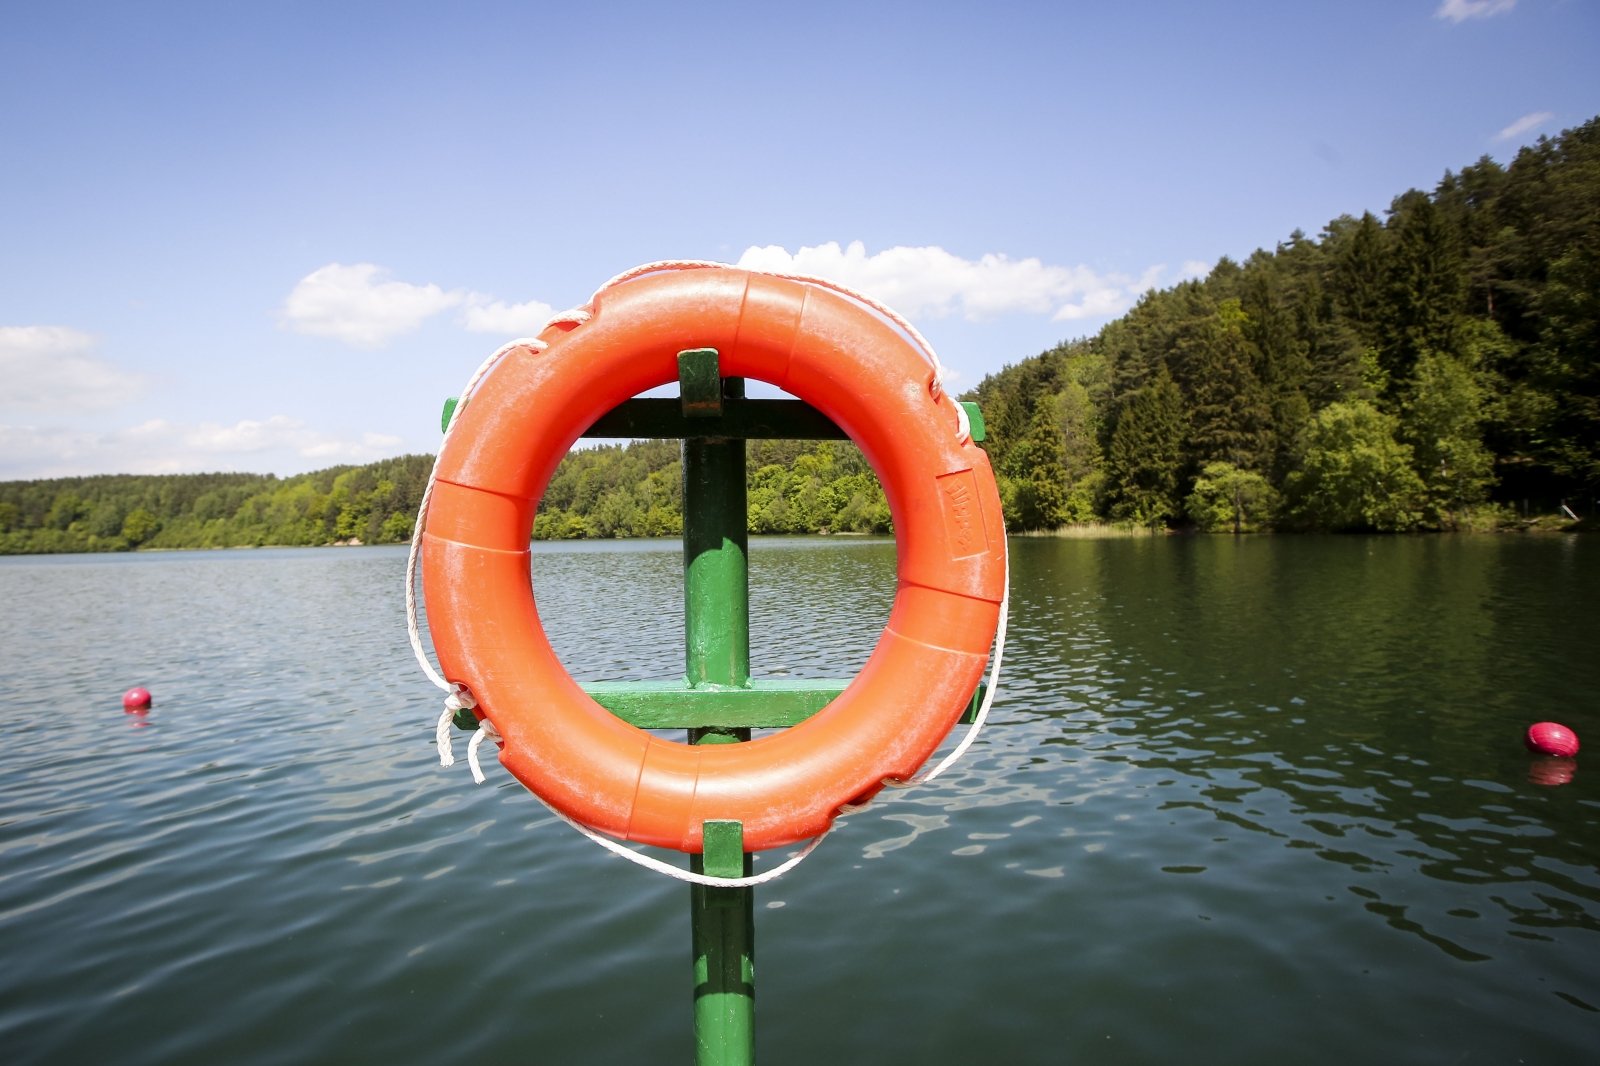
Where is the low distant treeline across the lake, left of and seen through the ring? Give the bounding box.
[0,440,890,555]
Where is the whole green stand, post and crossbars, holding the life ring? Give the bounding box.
[442,347,984,1066]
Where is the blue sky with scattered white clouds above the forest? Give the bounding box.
[0,0,1600,479]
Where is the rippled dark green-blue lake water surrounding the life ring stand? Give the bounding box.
[0,536,1600,1066]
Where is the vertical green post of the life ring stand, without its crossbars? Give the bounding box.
[678,351,755,1066]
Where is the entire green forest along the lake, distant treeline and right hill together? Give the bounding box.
[0,118,1600,554]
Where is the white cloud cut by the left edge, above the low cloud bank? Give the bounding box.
[0,327,144,411]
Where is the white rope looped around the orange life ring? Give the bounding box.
[405,259,1010,887]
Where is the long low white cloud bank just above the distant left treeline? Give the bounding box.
[0,415,405,479]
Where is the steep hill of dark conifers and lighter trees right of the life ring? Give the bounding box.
[966,118,1600,530]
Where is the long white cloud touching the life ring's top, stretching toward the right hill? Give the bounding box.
[739,240,1163,322]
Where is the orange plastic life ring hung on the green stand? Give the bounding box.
[422,267,1006,852]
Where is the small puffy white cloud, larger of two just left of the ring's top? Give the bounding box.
[278,262,467,349]
